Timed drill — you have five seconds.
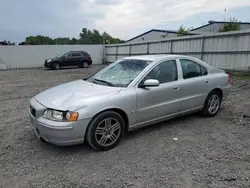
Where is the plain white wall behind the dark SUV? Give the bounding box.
[0,45,103,69]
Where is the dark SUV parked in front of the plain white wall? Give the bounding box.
[44,51,92,70]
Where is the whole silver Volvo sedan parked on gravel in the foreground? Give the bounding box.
[30,55,231,150]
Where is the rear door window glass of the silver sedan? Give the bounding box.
[180,59,207,79]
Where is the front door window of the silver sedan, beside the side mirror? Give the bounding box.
[143,60,178,84]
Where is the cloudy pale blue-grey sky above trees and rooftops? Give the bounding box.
[0,0,250,43]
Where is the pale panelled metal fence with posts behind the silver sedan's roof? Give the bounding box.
[105,30,250,70]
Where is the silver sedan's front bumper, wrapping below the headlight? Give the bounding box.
[30,99,91,146]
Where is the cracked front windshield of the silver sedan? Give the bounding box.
[87,59,150,87]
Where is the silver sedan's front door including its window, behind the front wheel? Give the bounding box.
[136,60,181,124]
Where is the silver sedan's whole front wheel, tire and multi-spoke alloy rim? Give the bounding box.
[86,111,125,150]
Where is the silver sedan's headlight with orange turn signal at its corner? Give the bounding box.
[43,109,79,121]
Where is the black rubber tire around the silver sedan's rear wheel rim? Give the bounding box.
[201,90,222,117]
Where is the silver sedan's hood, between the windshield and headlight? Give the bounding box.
[34,80,121,110]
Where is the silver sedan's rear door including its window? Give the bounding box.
[179,59,211,112]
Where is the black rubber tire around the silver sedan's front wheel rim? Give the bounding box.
[86,111,125,150]
